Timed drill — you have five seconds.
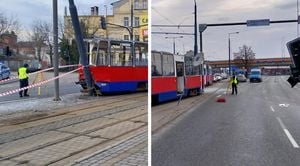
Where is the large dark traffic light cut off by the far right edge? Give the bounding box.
[286,37,300,87]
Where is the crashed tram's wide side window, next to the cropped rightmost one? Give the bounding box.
[111,44,132,66]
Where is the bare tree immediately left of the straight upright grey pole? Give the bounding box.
[30,20,53,66]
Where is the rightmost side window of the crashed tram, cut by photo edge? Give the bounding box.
[134,44,148,66]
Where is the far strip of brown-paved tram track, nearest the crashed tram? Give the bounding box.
[0,95,147,145]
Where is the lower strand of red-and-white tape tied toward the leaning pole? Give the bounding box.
[0,67,82,97]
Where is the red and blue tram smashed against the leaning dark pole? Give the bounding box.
[78,39,148,95]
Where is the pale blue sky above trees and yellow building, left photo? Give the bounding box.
[0,0,117,40]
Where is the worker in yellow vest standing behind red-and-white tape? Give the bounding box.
[18,63,29,97]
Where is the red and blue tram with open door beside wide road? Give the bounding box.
[151,51,202,103]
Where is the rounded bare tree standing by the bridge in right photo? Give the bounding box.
[234,45,255,71]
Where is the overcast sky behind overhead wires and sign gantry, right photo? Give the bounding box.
[151,0,297,60]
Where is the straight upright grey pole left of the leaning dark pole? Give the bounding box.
[52,0,60,101]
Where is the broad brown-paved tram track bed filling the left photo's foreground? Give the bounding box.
[0,94,148,165]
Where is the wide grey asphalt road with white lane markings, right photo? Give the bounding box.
[152,76,300,166]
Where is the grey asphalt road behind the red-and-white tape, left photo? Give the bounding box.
[0,72,81,103]
